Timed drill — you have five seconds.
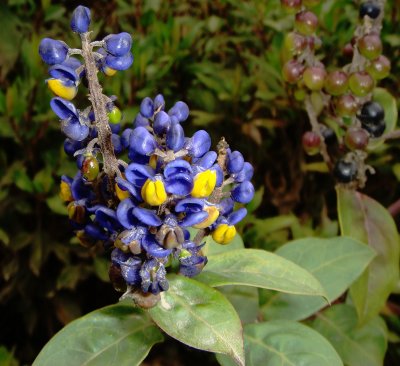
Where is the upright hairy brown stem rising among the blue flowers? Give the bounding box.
[81,32,120,179]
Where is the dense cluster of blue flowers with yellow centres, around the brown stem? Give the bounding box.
[39,6,254,294]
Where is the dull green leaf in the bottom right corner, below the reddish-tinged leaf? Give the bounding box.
[312,304,388,366]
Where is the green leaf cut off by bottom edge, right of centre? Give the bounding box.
[244,320,343,366]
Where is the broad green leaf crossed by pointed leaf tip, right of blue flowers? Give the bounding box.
[262,237,375,320]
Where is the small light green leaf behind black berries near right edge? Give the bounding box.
[368,88,398,150]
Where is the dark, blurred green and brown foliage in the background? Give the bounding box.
[0,0,400,366]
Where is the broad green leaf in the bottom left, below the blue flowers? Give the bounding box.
[33,304,163,366]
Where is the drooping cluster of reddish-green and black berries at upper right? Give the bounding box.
[281,0,390,186]
